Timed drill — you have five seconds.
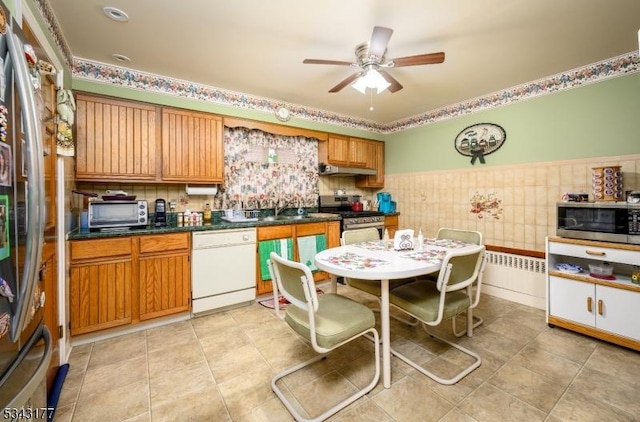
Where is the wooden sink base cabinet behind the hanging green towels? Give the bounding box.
[256,221,340,295]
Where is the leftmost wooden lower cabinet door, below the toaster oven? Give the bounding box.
[69,258,132,335]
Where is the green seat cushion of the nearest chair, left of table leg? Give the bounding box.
[285,293,376,349]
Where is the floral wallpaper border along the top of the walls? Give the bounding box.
[34,0,640,134]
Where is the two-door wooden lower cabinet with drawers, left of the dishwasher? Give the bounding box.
[69,233,191,335]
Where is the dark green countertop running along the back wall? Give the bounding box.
[68,213,341,240]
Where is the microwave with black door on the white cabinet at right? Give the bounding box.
[556,202,640,245]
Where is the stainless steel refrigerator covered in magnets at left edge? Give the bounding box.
[0,2,52,420]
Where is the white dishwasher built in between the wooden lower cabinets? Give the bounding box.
[191,228,256,314]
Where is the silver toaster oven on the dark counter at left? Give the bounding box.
[88,200,149,230]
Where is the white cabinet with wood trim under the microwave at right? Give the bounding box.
[547,237,640,350]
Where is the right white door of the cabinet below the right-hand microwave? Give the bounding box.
[595,285,640,340]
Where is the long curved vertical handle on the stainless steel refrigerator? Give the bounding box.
[7,30,44,342]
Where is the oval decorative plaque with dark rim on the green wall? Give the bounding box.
[454,123,507,164]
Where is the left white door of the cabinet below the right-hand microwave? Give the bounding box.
[549,276,596,327]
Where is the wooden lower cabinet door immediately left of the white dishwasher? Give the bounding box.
[138,252,191,321]
